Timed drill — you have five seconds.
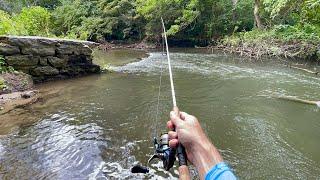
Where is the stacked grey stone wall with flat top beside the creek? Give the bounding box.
[0,36,100,82]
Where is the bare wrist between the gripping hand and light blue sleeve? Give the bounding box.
[192,138,223,179]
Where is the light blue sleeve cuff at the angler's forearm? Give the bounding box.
[205,162,237,180]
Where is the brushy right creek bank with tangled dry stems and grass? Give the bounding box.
[218,30,320,62]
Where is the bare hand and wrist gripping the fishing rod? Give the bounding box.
[167,108,223,179]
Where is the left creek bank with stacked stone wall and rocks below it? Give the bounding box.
[0,36,101,114]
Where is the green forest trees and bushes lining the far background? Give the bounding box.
[0,0,320,45]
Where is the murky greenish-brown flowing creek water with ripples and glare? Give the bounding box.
[0,50,320,179]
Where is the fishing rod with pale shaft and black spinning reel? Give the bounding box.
[131,17,190,180]
